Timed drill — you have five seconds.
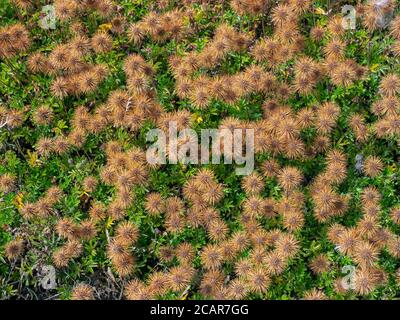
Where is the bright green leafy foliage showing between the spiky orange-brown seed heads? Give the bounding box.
[0,0,400,300]
